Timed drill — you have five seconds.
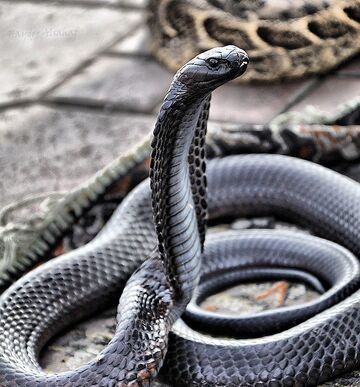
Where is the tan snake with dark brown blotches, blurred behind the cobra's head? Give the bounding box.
[149,0,360,81]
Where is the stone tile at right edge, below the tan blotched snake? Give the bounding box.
[291,76,360,112]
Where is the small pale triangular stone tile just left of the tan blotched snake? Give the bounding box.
[110,25,151,55]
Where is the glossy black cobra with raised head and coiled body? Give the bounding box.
[0,46,360,387]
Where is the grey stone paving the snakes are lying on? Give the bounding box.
[0,0,360,386]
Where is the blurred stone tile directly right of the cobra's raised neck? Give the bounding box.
[210,81,306,124]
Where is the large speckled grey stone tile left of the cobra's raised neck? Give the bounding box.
[0,106,154,208]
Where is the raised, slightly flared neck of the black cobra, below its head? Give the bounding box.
[150,81,211,303]
